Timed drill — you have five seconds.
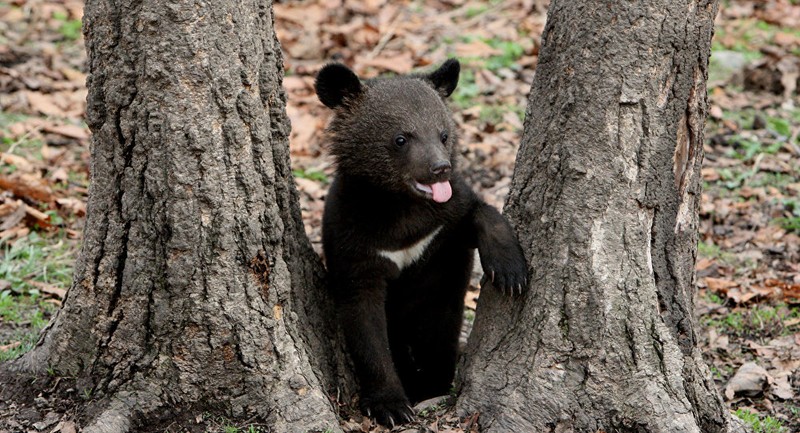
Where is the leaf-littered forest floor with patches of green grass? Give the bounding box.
[0,0,800,433]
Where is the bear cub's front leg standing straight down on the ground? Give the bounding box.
[336,279,414,426]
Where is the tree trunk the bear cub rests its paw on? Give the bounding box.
[458,0,740,433]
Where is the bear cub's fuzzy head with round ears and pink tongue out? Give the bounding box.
[316,59,461,203]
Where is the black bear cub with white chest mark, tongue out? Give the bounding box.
[316,59,528,425]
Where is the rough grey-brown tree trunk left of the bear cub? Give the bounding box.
[0,0,338,432]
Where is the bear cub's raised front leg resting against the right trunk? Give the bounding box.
[473,202,528,295]
